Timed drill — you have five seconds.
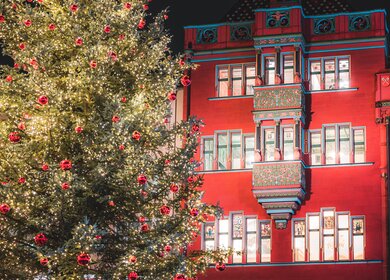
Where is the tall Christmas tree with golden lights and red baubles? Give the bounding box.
[0,0,226,279]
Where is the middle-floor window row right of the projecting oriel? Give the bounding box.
[309,124,366,165]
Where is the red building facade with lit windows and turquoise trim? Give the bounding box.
[184,0,390,279]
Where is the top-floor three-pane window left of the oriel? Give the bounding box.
[217,64,256,97]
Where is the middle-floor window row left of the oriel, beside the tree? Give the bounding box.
[201,131,255,171]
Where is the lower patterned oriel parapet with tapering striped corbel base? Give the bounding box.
[252,160,306,229]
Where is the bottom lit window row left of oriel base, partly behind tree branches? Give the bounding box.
[202,213,271,263]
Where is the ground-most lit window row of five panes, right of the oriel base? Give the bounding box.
[292,209,365,262]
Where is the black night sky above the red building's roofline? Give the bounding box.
[150,0,390,52]
